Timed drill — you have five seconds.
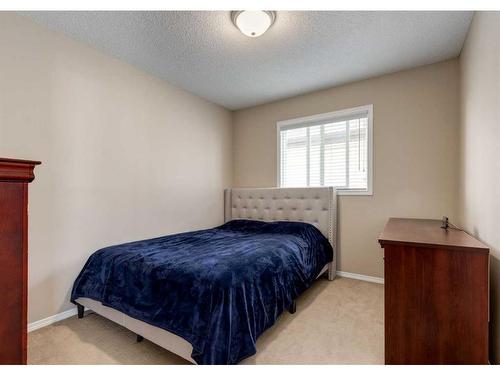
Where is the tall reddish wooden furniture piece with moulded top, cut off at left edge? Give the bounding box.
[0,158,40,365]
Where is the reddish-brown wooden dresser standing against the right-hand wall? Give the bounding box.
[379,218,489,364]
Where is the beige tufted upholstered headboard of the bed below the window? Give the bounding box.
[224,187,337,277]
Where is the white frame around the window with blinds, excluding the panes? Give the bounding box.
[276,104,373,195]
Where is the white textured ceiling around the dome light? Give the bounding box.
[27,11,472,109]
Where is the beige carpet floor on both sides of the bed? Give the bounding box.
[28,278,384,364]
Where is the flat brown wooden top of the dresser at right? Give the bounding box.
[378,218,489,253]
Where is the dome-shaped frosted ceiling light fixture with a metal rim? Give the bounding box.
[231,10,276,38]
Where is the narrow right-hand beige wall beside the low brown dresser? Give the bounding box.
[459,12,500,363]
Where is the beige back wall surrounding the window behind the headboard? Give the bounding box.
[233,60,459,277]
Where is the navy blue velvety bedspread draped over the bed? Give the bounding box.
[71,220,332,364]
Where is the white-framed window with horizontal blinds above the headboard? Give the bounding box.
[278,105,373,195]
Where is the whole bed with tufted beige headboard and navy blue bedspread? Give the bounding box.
[71,187,336,364]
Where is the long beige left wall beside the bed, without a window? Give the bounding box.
[0,13,232,321]
